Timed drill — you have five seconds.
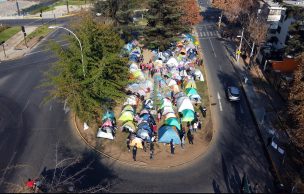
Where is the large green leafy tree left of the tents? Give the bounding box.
[43,15,129,126]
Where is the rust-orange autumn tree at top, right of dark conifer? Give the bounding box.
[181,0,203,25]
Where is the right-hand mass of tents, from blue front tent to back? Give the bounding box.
[154,35,204,144]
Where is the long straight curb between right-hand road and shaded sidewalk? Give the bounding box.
[225,45,282,187]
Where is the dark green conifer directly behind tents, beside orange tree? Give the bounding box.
[144,0,189,50]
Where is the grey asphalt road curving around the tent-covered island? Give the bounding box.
[0,1,273,193]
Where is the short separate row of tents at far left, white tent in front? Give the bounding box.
[97,110,116,140]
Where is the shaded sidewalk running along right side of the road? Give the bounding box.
[226,40,294,192]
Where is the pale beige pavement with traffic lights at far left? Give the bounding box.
[0,26,37,61]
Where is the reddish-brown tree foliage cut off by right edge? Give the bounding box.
[287,53,304,149]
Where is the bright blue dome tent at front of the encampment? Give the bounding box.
[158,125,181,144]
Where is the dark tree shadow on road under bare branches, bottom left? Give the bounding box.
[39,151,118,193]
